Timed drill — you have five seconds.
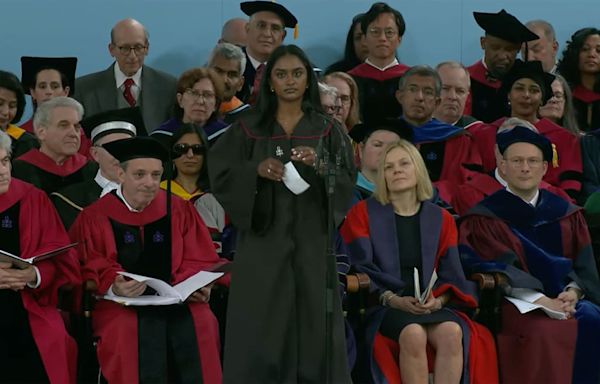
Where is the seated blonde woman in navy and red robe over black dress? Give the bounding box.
[341,140,497,383]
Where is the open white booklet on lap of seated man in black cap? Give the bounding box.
[102,271,223,305]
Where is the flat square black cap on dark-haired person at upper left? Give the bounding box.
[21,56,77,94]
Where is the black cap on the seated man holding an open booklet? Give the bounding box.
[102,137,169,163]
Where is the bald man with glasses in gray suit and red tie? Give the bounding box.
[74,19,176,132]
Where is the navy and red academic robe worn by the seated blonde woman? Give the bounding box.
[340,198,498,383]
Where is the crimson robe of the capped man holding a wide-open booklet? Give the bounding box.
[69,190,221,384]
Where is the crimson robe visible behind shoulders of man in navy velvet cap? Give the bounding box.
[450,171,572,216]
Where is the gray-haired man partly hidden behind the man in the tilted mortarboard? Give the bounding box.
[521,20,558,74]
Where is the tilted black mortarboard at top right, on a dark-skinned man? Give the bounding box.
[473,9,540,44]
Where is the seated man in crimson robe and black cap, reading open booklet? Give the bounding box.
[69,137,221,384]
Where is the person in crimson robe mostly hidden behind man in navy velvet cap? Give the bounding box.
[451,117,571,216]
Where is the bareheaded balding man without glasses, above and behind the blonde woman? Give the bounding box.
[433,61,478,128]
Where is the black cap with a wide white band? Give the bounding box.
[81,107,147,144]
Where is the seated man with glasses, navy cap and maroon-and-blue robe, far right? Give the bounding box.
[459,127,600,383]
